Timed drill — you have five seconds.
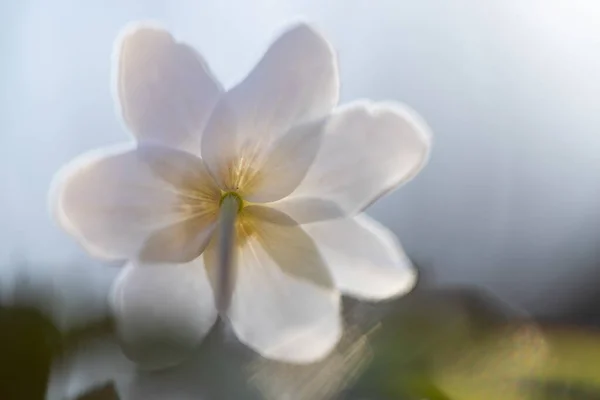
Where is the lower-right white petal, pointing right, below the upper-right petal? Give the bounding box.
[304,215,417,300]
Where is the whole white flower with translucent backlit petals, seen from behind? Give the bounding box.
[51,24,431,365]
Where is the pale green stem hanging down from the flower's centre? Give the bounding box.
[216,194,241,315]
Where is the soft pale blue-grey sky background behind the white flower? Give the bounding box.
[0,0,600,318]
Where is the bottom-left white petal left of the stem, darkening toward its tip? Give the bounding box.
[110,257,217,369]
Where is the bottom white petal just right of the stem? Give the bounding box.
[228,214,341,363]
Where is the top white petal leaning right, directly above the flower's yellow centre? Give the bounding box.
[202,25,339,201]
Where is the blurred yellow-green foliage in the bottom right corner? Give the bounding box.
[346,291,600,400]
